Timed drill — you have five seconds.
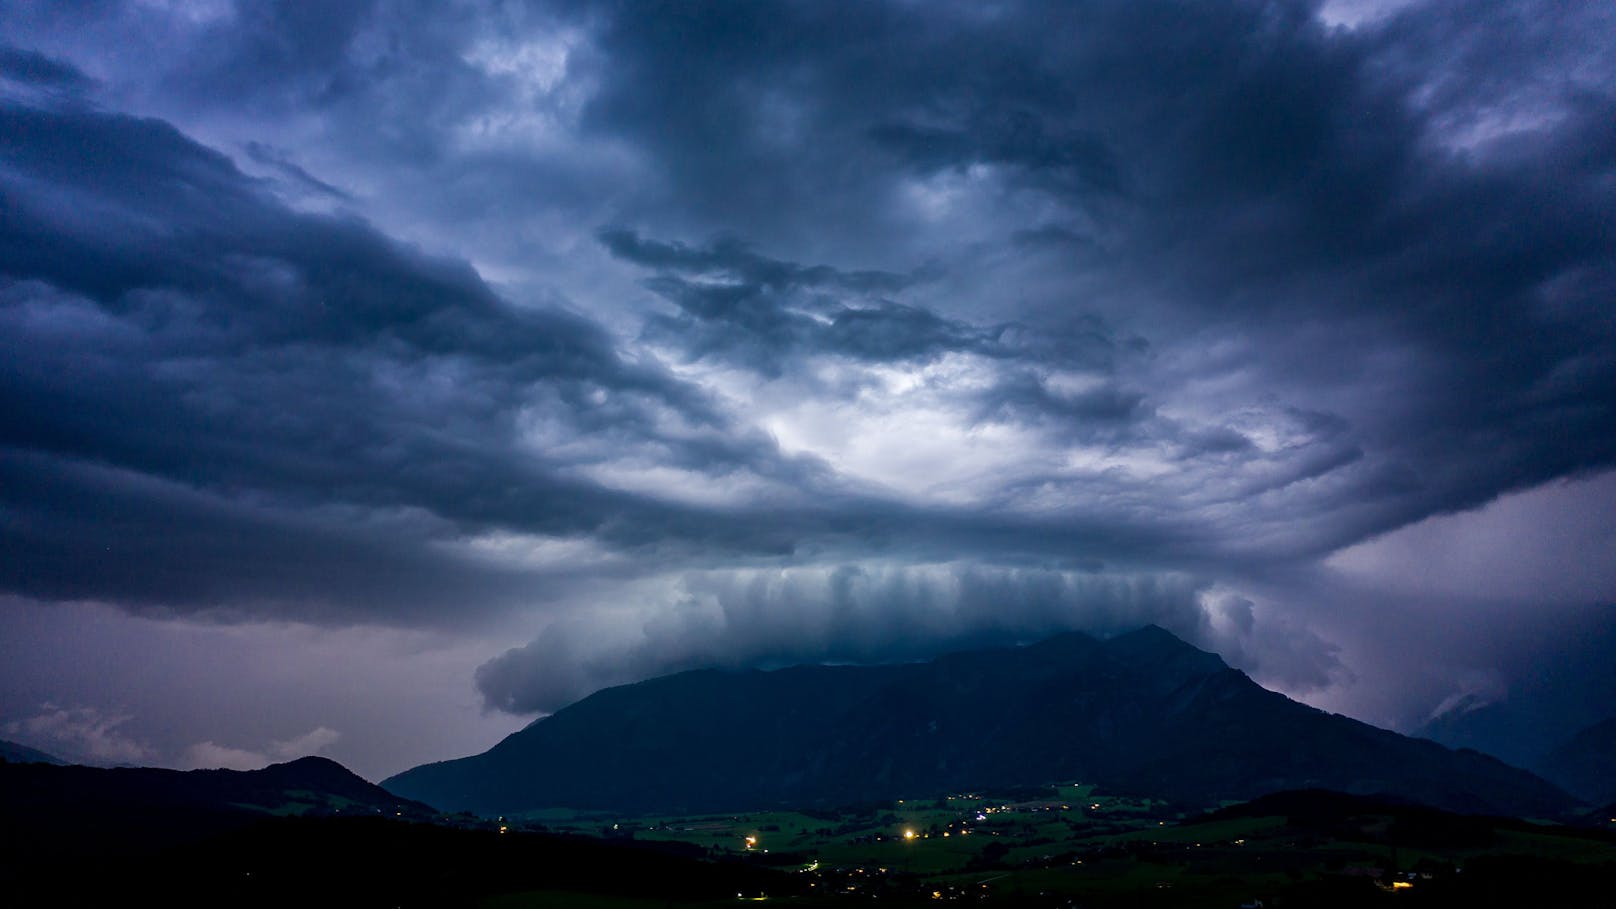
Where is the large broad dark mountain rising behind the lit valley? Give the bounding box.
[383,626,1571,815]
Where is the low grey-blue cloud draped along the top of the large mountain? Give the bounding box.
[477,563,1340,713]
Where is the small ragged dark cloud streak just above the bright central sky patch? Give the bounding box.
[600,228,1149,437]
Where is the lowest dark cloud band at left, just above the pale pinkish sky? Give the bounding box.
[0,448,525,623]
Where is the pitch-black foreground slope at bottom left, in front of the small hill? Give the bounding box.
[0,805,788,909]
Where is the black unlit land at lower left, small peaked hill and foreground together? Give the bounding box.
[0,759,793,907]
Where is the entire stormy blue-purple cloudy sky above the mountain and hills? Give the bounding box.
[0,0,1616,778]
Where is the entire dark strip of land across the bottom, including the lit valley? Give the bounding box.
[0,762,1616,909]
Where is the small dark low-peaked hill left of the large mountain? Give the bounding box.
[0,757,436,860]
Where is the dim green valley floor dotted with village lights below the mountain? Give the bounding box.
[471,783,1616,909]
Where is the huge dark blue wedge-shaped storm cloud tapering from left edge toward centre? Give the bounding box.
[0,92,859,611]
